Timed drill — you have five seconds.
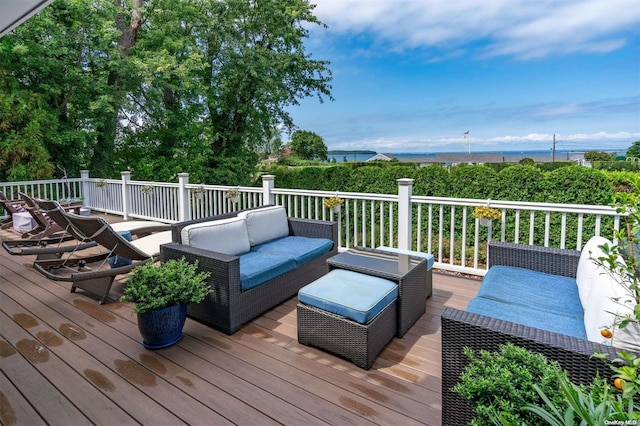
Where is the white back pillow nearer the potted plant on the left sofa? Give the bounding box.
[180,217,251,256]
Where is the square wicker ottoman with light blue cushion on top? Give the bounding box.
[297,269,398,370]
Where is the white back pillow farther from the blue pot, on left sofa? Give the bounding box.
[238,206,289,246]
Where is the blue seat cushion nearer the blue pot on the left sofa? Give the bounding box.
[240,251,297,290]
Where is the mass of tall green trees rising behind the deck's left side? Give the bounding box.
[0,0,331,184]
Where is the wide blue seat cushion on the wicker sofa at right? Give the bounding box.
[478,265,584,321]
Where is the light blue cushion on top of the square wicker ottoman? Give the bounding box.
[298,269,398,324]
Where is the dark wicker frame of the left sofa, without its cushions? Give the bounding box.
[160,207,338,334]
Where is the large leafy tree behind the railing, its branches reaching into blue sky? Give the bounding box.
[117,0,331,184]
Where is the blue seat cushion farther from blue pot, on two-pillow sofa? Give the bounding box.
[251,236,333,266]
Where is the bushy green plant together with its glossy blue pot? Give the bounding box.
[120,258,212,349]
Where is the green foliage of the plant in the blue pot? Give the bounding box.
[120,258,212,314]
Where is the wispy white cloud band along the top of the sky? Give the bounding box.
[315,0,640,60]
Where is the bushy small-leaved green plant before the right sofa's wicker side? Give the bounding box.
[453,343,562,426]
